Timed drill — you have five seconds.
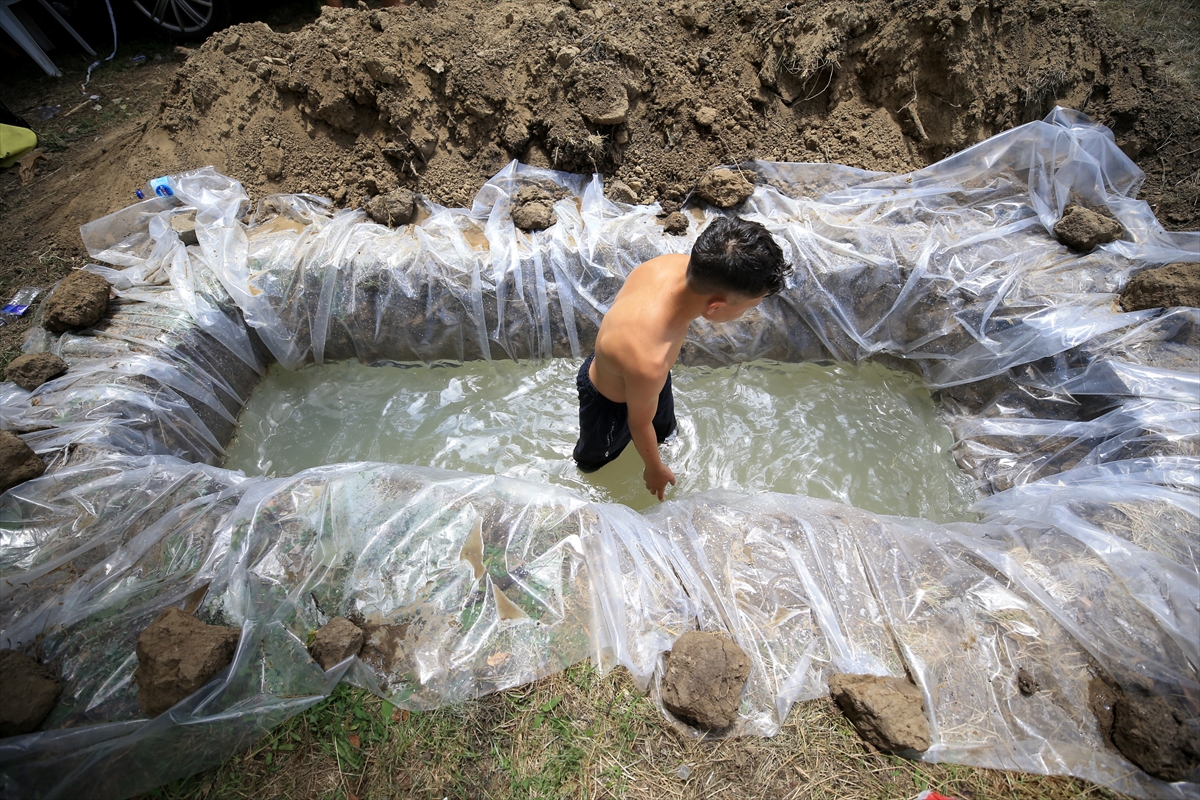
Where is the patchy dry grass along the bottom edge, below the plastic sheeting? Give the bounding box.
[149,664,1122,800]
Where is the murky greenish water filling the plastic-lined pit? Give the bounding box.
[226,360,971,521]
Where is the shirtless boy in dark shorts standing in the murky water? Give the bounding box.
[575,217,791,500]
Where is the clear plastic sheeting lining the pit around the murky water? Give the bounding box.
[0,109,1200,798]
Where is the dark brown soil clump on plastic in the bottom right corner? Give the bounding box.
[1088,678,1200,781]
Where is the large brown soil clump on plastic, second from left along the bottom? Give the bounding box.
[133,607,241,717]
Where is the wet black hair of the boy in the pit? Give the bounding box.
[688,215,792,297]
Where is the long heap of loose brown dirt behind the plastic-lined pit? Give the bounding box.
[125,0,1198,219]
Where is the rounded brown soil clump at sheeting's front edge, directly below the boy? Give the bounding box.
[661,631,750,730]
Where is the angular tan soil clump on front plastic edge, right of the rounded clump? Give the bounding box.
[829,674,930,753]
